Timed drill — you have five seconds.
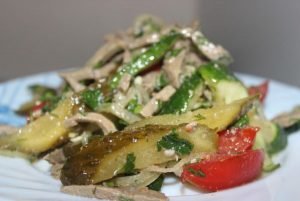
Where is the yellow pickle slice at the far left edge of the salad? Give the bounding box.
[0,97,73,155]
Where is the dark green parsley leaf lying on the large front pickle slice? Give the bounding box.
[157,130,194,155]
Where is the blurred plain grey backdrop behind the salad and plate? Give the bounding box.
[0,0,300,86]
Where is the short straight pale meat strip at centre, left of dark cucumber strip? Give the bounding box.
[140,85,176,117]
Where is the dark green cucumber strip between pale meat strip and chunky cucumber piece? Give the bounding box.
[160,71,203,114]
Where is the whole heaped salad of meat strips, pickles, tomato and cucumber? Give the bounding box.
[0,15,300,201]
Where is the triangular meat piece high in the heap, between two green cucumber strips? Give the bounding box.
[162,49,186,88]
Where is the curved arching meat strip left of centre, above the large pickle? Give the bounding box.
[65,112,117,135]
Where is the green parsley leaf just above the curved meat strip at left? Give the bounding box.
[81,89,103,110]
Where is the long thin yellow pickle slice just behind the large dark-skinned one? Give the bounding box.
[127,97,256,131]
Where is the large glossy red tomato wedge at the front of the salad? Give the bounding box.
[181,150,264,191]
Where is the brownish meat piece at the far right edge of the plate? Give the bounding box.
[272,106,300,127]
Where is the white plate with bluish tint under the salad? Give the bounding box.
[0,73,300,201]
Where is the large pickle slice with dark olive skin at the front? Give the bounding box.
[61,125,218,185]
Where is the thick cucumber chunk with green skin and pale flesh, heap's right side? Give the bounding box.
[200,63,248,104]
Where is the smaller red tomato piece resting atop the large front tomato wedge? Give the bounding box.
[218,127,259,154]
